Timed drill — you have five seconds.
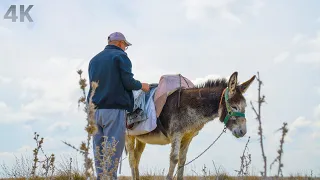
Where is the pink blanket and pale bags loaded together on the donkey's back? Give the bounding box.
[126,74,194,136]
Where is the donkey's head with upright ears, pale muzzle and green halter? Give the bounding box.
[219,72,256,138]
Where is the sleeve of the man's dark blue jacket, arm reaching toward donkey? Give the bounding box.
[118,54,142,90]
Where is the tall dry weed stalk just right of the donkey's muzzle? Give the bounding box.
[250,72,267,177]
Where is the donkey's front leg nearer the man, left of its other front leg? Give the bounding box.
[167,133,182,180]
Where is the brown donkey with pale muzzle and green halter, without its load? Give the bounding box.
[125,72,255,180]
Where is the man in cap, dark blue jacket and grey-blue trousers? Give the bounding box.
[88,32,149,179]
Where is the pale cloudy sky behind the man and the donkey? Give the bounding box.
[0,0,320,176]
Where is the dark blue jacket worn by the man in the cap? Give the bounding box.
[87,45,142,112]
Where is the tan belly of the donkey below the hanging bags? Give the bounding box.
[135,131,170,145]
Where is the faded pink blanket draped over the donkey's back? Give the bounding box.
[154,74,194,118]
